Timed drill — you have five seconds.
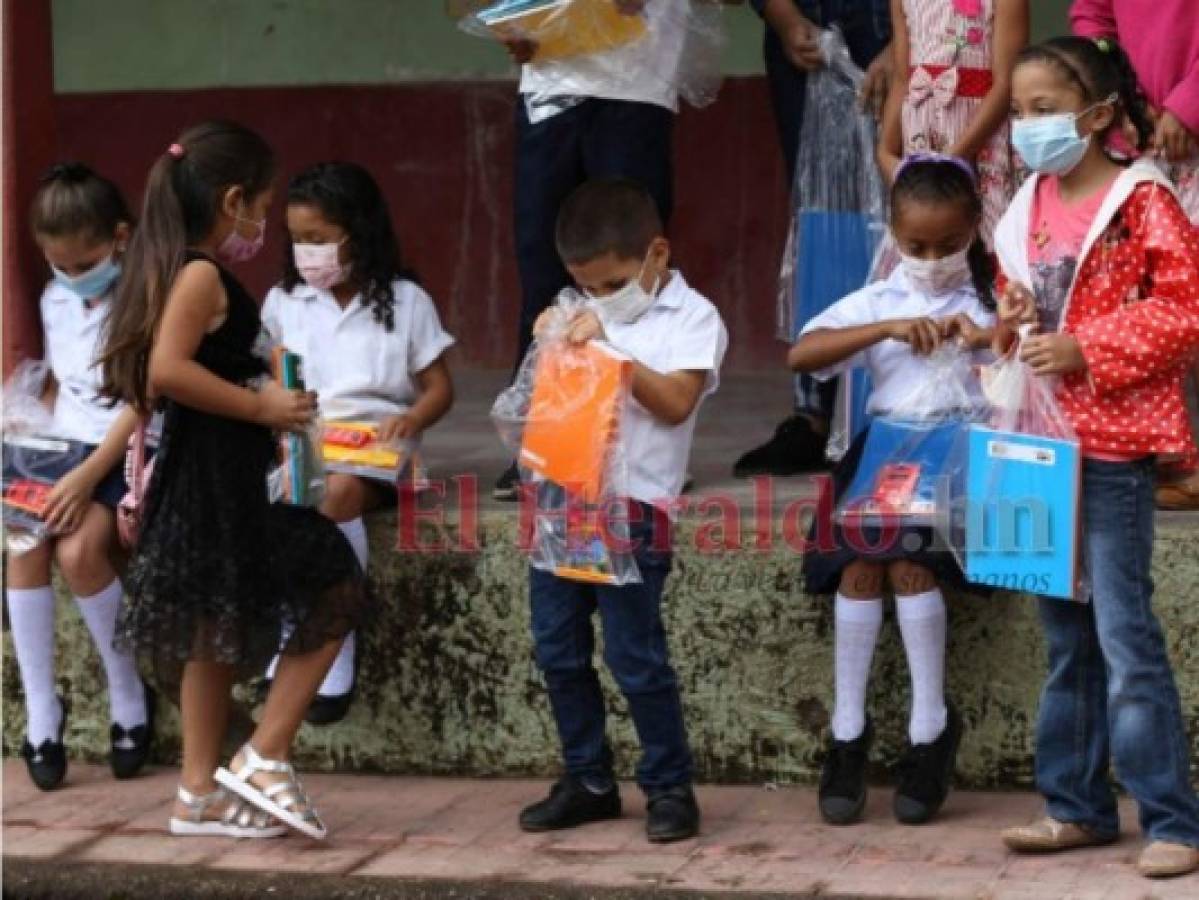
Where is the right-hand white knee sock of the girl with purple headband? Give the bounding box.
[896,587,948,744]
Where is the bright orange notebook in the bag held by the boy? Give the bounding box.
[520,340,633,503]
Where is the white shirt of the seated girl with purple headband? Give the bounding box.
[800,266,995,415]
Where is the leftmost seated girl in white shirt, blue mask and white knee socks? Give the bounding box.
[7,163,153,790]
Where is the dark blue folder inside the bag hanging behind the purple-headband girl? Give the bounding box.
[794,210,876,334]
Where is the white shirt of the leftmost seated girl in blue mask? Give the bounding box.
[41,280,121,443]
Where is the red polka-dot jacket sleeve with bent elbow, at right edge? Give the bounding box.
[1073,185,1199,395]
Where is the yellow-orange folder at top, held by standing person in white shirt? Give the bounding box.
[477,0,645,60]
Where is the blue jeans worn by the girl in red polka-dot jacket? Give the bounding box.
[1036,458,1199,847]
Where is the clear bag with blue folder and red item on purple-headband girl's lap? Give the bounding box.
[836,342,987,539]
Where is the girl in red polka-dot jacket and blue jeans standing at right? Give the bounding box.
[995,37,1199,876]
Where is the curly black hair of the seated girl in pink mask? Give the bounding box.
[282,162,418,331]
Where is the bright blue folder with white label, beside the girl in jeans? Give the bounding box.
[965,425,1081,600]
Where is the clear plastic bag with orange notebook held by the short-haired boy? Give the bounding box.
[492,289,641,585]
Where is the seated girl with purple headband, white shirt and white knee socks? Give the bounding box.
[788,153,994,825]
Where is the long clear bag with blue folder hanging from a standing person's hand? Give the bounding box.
[776,28,886,340]
